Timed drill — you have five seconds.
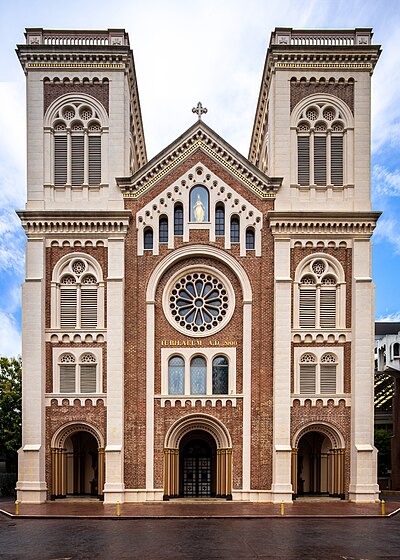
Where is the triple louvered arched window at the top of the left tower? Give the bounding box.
[53,102,102,187]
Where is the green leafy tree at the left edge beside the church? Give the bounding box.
[0,357,22,471]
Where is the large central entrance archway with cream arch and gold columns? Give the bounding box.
[164,414,232,500]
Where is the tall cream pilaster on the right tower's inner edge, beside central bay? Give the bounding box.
[271,238,292,502]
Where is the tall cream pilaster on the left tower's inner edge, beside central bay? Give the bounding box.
[104,238,125,503]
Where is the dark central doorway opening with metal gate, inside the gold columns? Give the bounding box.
[179,430,217,498]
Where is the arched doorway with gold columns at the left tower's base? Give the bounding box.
[51,425,104,500]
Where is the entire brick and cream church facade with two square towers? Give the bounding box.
[17,28,380,503]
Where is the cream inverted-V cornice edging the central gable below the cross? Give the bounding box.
[117,121,282,198]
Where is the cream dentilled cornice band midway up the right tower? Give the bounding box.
[268,211,381,238]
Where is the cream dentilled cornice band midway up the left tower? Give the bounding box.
[17,210,132,237]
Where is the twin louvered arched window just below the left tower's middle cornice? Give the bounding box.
[53,258,99,330]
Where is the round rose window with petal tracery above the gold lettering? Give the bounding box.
[163,269,234,336]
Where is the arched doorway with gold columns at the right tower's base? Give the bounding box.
[292,426,344,498]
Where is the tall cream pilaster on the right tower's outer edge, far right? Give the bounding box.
[349,238,379,502]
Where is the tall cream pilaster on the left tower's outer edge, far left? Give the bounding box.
[17,239,47,503]
